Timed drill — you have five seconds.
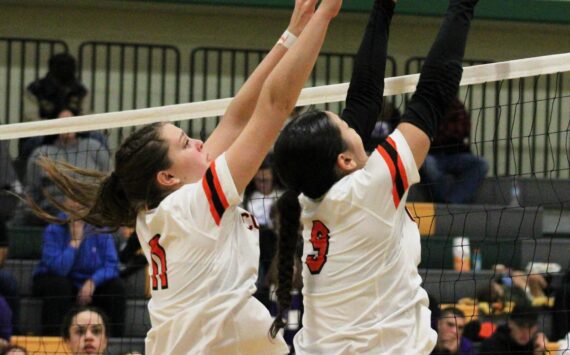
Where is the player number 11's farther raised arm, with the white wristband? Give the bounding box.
[204,0,317,159]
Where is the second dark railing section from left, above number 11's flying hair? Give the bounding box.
[78,42,180,146]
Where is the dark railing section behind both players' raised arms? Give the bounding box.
[188,47,397,139]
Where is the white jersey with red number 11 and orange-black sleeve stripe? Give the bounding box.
[136,155,288,355]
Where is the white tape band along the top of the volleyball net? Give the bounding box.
[0,53,570,140]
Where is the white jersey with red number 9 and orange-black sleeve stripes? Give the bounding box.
[294,130,437,354]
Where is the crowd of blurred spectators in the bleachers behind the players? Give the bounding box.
[0,53,570,354]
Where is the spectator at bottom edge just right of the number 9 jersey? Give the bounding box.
[432,307,475,355]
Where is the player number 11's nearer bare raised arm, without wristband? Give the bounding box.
[226,0,342,193]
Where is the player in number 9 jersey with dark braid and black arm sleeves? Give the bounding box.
[271,0,477,354]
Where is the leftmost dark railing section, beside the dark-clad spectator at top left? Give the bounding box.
[0,37,68,124]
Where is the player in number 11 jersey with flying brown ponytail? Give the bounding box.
[26,0,341,354]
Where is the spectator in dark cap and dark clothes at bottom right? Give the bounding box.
[480,304,548,355]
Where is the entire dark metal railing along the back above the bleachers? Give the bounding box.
[0,38,570,178]
